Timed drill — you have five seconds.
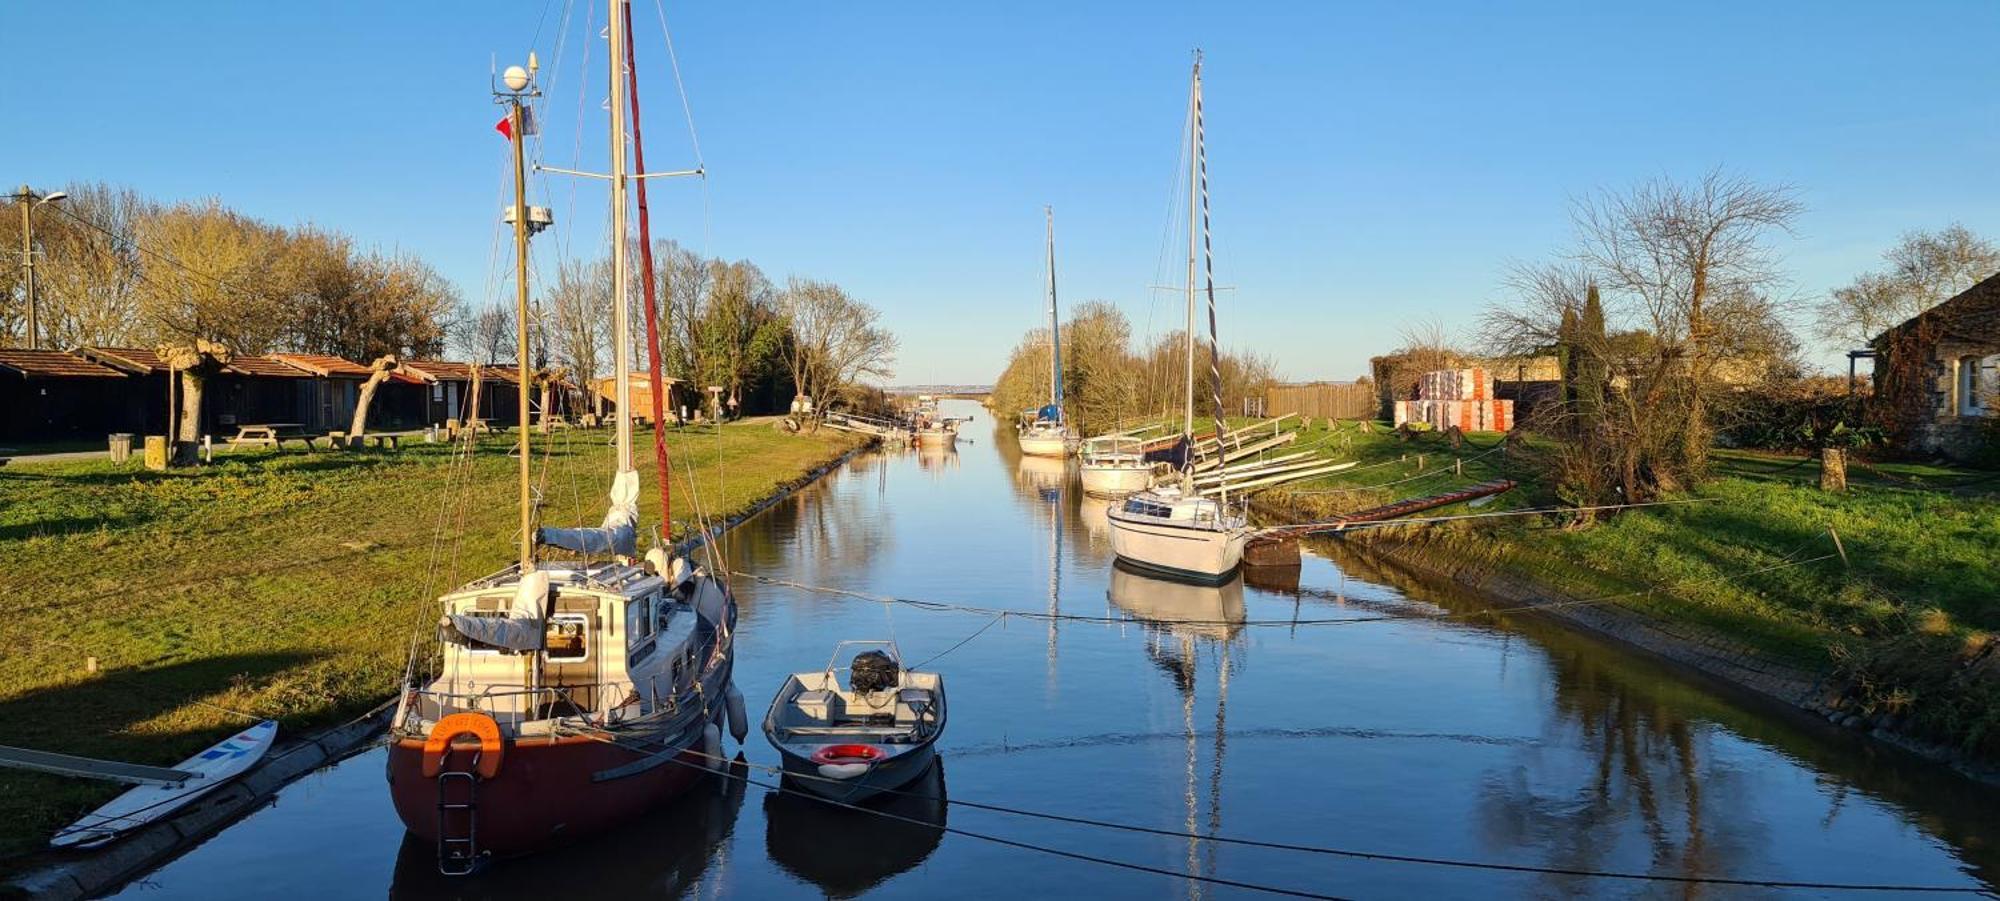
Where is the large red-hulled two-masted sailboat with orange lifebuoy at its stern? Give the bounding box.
[386,0,748,875]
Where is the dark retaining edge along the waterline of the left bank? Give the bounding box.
[0,432,880,901]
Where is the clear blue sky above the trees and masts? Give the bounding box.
[0,0,2000,382]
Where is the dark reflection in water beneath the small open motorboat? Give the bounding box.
[764,759,948,897]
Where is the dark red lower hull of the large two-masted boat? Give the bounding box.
[388,737,704,857]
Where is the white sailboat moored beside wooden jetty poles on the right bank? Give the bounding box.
[1108,54,1250,583]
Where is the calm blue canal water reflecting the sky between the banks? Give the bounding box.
[124,404,2000,899]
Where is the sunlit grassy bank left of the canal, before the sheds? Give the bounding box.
[0,420,852,869]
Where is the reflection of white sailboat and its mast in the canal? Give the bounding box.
[1108,561,1248,884]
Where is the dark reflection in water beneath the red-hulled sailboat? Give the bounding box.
[386,755,750,901]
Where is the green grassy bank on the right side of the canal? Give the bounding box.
[1268,424,2000,761]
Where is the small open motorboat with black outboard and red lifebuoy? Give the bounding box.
[764,641,944,803]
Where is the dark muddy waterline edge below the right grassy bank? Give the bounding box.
[1256,501,2000,787]
